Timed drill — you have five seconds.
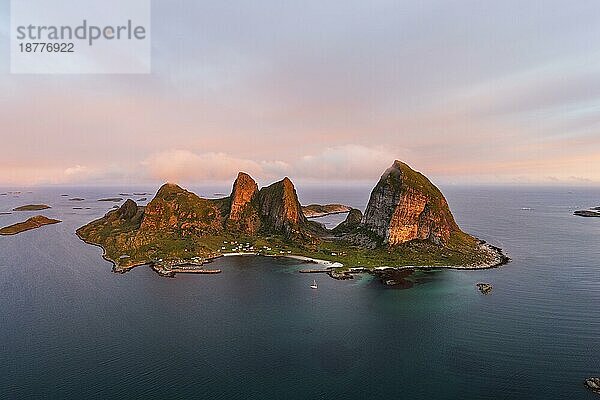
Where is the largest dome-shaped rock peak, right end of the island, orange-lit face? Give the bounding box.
[361,161,460,246]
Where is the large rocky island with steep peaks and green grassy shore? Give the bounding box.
[77,161,509,282]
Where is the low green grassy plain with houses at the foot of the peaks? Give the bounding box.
[78,211,487,268]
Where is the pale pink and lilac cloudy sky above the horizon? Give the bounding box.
[0,0,600,186]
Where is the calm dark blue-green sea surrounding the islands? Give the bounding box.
[0,186,600,399]
